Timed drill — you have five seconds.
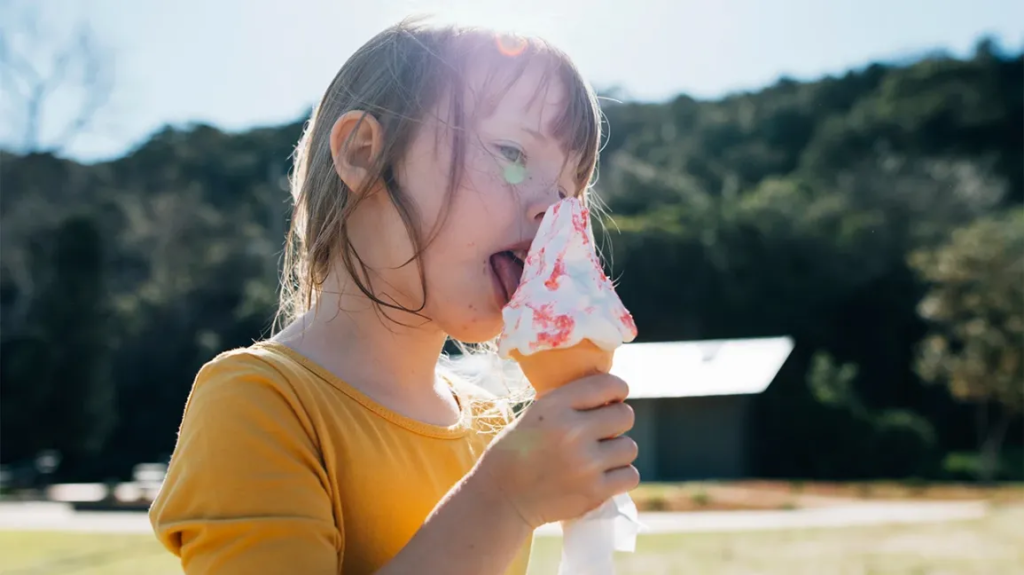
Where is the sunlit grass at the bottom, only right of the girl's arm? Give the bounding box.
[530,506,1024,575]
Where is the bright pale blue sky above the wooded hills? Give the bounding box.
[0,0,1024,162]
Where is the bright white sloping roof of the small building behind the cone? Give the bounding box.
[611,337,793,399]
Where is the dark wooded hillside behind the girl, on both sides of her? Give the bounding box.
[0,43,1024,479]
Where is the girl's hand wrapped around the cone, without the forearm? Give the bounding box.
[473,374,640,529]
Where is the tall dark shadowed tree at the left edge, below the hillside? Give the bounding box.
[2,216,117,472]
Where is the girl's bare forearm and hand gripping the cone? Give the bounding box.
[378,375,640,575]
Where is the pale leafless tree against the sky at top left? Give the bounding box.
[0,2,114,154]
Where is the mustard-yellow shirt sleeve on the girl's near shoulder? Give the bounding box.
[150,354,343,575]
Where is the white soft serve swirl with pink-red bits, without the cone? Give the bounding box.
[498,197,637,357]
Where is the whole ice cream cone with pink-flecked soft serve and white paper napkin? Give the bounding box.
[498,197,640,575]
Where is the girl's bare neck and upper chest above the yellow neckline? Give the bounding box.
[273,293,459,425]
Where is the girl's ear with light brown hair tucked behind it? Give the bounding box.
[331,109,383,192]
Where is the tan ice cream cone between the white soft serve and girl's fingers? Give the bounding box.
[510,340,613,395]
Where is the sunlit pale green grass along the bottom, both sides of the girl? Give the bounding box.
[0,505,1024,575]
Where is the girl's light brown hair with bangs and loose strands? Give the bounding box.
[275,18,601,413]
